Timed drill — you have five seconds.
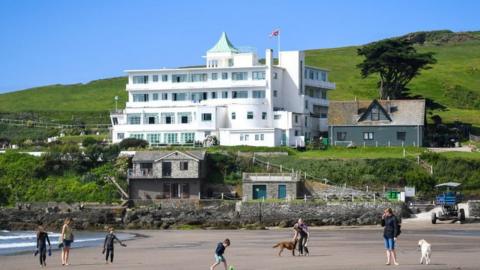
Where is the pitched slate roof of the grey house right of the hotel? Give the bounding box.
[328,99,425,126]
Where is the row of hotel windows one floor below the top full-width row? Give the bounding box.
[132,90,265,102]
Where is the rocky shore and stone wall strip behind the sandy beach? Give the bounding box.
[0,200,405,230]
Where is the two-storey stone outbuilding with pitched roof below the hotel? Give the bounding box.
[128,151,206,201]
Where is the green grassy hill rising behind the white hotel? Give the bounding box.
[0,31,480,127]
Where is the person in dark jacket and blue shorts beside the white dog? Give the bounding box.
[382,208,400,265]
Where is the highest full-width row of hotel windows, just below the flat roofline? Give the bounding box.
[132,71,265,84]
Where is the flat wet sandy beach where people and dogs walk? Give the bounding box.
[0,220,480,270]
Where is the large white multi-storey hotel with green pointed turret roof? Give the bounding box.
[111,33,335,146]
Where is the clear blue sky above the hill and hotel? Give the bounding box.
[0,0,480,92]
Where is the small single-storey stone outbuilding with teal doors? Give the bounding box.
[242,173,300,200]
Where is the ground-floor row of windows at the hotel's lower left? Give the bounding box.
[117,132,195,145]
